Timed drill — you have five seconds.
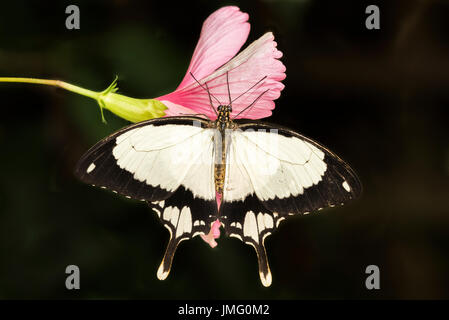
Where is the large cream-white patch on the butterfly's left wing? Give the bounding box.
[112,125,215,200]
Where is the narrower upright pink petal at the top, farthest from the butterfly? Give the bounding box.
[177,6,250,90]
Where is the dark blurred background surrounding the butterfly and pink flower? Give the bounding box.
[0,0,449,299]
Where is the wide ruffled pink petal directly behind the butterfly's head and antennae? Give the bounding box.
[157,32,286,120]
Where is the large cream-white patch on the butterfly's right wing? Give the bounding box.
[224,130,327,201]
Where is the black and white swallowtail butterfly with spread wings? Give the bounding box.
[75,77,362,286]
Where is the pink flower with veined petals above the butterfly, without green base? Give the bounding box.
[156,6,285,120]
